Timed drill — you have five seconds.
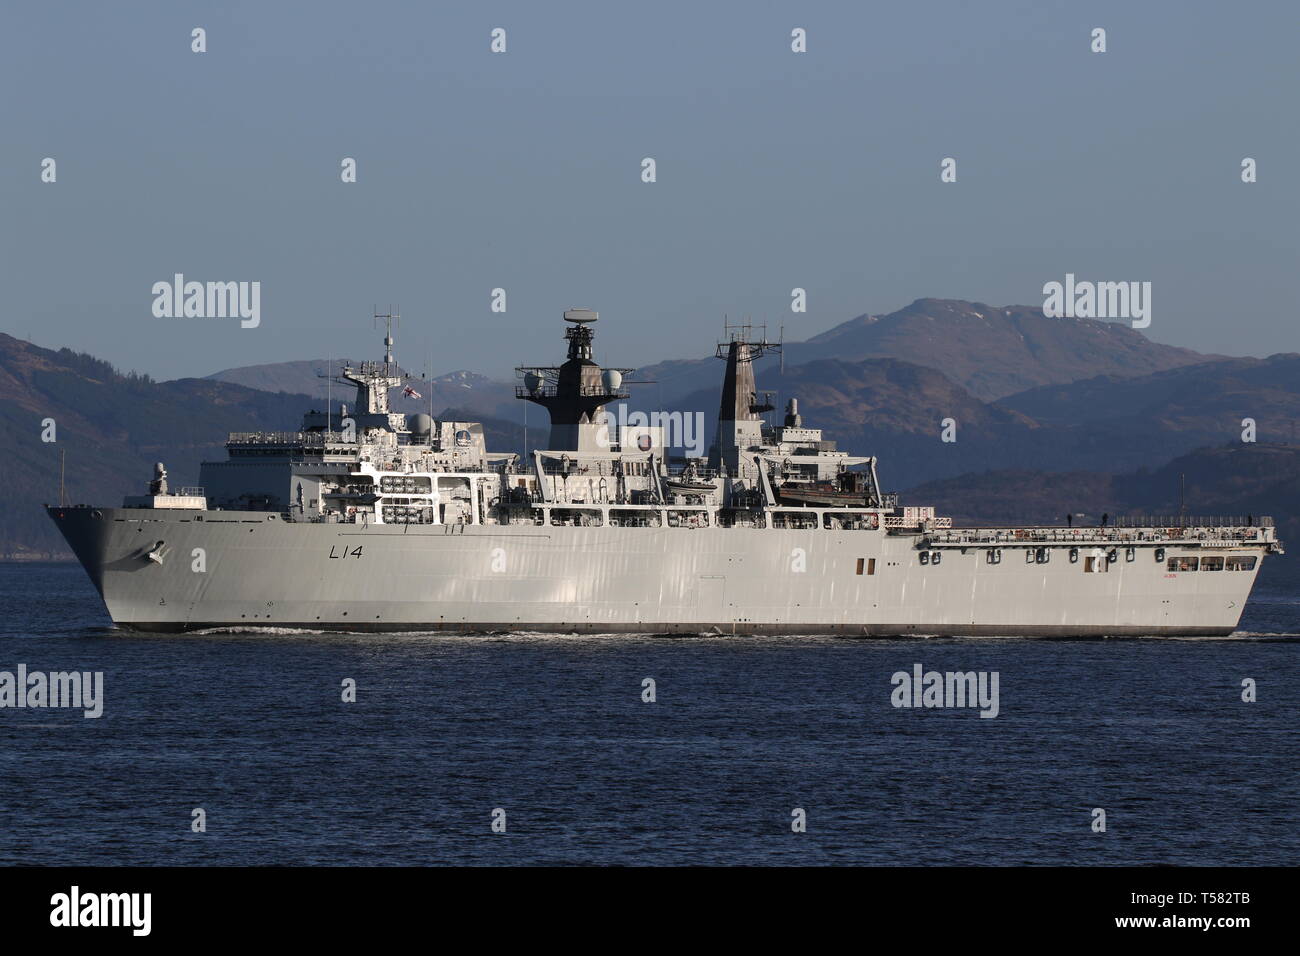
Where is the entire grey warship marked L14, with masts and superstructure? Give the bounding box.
[47,310,1282,637]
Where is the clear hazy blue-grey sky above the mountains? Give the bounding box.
[0,0,1300,377]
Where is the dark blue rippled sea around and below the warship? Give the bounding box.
[0,557,1300,865]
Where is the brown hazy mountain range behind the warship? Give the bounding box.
[0,299,1300,557]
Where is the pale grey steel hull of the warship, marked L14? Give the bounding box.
[51,509,1264,636]
